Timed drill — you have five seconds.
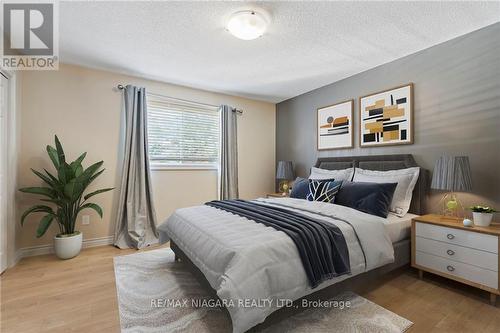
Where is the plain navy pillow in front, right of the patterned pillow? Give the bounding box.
[335,182,398,218]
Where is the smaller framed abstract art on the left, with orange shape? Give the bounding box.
[316,99,354,150]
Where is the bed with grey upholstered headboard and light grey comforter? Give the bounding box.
[159,155,428,332]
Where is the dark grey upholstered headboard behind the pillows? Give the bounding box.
[315,154,429,215]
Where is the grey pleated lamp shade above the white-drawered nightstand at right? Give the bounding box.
[431,156,472,192]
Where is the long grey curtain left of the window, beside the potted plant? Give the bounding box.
[114,85,158,249]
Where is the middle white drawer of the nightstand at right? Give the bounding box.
[415,236,498,272]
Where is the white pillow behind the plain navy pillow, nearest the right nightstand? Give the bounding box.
[352,167,420,217]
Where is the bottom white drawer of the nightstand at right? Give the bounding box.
[415,251,498,289]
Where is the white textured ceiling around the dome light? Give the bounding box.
[59,1,500,102]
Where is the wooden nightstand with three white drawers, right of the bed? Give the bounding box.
[411,215,500,305]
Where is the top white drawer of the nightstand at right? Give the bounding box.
[415,222,498,253]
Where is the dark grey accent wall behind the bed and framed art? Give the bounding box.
[276,23,500,211]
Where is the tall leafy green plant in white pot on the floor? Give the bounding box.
[19,135,112,259]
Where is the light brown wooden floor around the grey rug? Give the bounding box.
[0,246,500,333]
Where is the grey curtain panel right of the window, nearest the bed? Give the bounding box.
[219,105,238,200]
